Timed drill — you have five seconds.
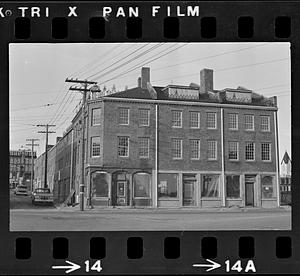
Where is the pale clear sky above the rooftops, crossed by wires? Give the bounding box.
[9,42,292,159]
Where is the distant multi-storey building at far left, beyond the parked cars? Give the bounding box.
[9,149,36,189]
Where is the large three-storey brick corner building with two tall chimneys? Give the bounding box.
[34,68,279,208]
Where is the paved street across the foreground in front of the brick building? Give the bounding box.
[10,192,291,231]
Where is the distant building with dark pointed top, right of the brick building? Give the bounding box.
[280,151,292,205]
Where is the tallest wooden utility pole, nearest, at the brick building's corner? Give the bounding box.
[66,78,97,211]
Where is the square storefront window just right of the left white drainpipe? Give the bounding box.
[158,173,178,197]
